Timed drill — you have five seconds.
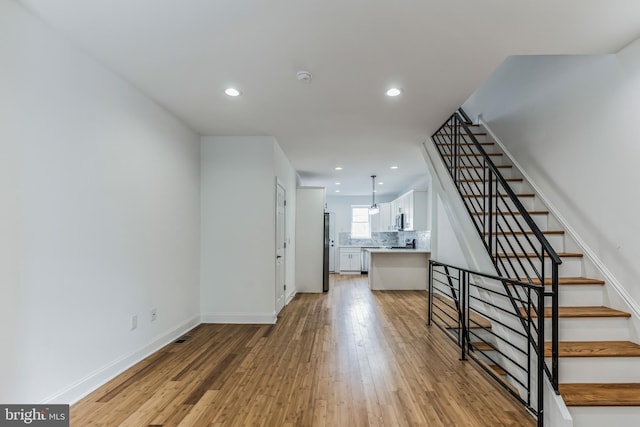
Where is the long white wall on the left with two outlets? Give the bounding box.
[0,0,199,403]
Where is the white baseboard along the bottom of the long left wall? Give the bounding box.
[43,315,200,405]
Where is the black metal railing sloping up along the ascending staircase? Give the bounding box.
[432,109,562,422]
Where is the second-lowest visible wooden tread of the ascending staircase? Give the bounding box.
[544,341,640,357]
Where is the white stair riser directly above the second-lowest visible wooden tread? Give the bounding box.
[545,317,629,341]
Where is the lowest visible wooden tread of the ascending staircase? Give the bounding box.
[560,383,640,406]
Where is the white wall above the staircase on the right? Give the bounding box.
[464,36,640,310]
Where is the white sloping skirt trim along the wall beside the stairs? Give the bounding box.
[477,118,640,318]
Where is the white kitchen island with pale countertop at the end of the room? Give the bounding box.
[366,248,431,291]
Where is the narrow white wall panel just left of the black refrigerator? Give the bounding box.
[296,187,325,293]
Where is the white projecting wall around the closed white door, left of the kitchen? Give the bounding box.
[200,137,295,323]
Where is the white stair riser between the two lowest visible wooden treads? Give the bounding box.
[547,357,640,384]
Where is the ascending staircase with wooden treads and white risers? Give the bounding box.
[432,112,640,427]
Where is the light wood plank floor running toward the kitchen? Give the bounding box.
[71,275,535,427]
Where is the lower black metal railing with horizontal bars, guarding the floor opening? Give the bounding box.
[428,260,544,426]
